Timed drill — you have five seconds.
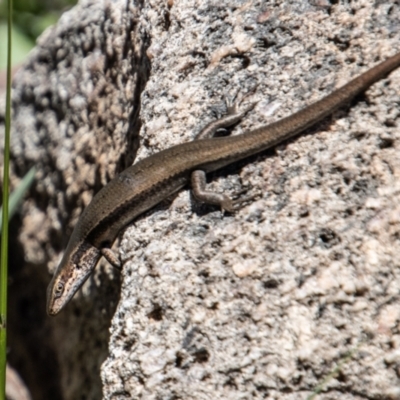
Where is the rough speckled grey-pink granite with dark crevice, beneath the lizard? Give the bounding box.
[2,0,400,400]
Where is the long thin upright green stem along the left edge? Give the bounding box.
[0,0,12,400]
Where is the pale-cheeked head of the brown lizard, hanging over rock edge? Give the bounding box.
[47,242,101,315]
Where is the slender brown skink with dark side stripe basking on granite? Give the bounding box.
[47,53,400,315]
